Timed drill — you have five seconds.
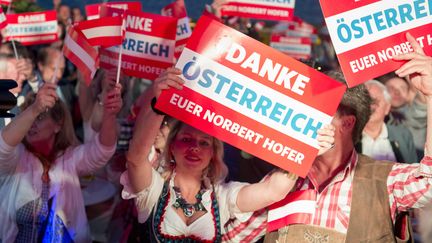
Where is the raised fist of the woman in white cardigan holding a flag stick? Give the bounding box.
[31,83,58,115]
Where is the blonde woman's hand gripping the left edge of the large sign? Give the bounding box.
[153,67,185,98]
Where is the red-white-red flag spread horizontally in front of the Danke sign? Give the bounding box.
[76,16,123,47]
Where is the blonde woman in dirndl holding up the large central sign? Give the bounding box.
[121,68,333,242]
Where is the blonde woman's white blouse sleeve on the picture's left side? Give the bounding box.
[120,169,164,223]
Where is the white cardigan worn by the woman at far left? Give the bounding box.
[0,134,115,243]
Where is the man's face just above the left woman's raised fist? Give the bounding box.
[38,50,65,83]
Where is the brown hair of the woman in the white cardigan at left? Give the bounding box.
[20,92,79,155]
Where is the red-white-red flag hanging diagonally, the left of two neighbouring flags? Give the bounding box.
[63,27,99,85]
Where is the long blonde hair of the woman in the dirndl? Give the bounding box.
[164,120,228,184]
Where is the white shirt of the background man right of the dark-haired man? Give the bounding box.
[362,124,396,161]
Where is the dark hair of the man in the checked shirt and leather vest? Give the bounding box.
[326,71,372,144]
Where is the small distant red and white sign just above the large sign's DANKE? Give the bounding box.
[270,35,312,59]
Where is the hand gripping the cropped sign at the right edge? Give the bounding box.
[393,33,432,97]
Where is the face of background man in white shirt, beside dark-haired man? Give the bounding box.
[366,85,391,122]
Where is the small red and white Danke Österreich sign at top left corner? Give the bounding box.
[5,10,58,45]
